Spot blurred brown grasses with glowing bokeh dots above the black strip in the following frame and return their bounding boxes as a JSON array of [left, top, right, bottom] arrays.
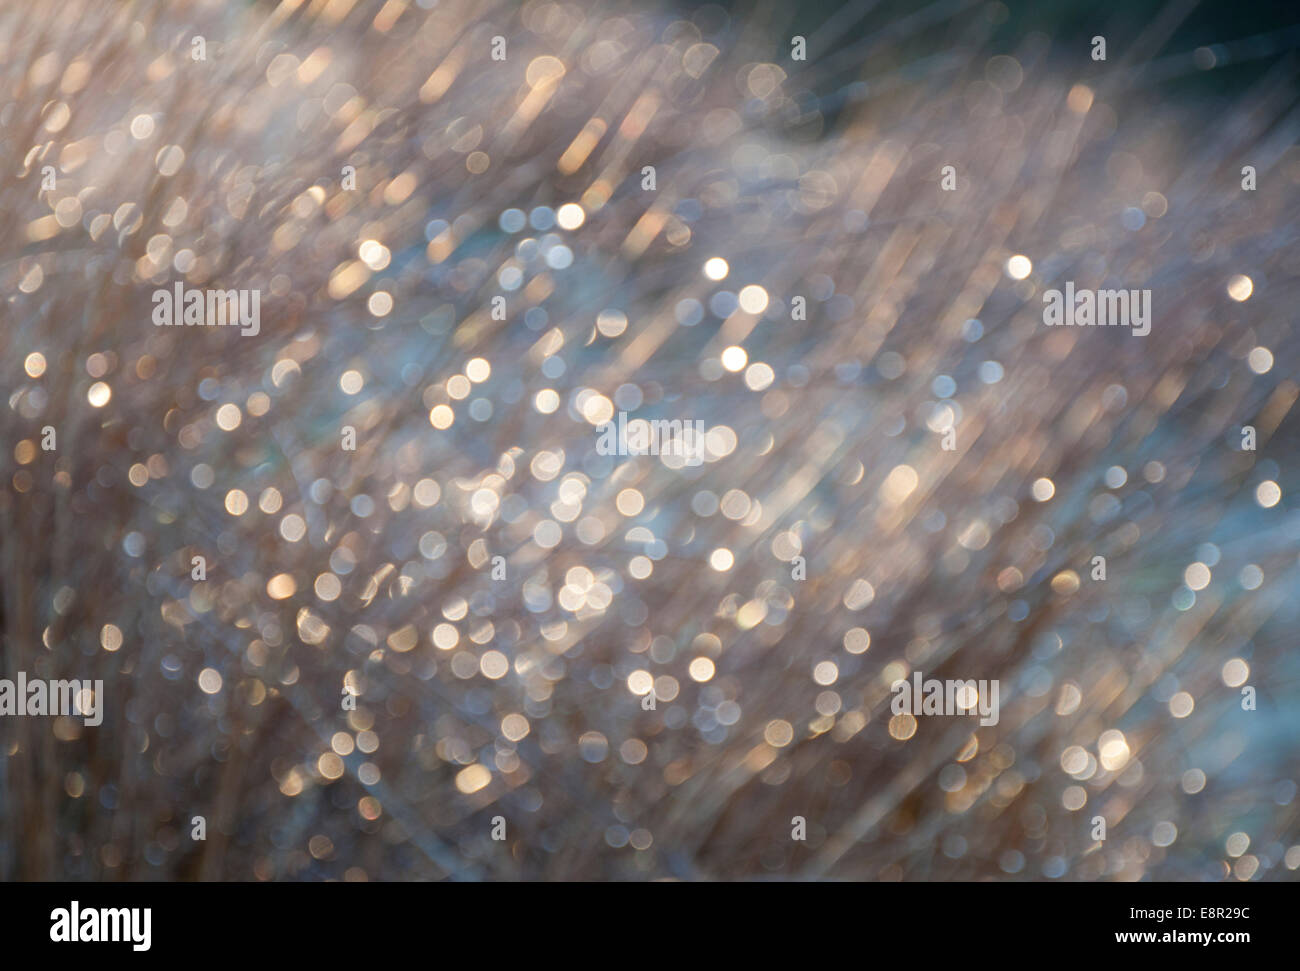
[[0, 0, 1300, 880]]
